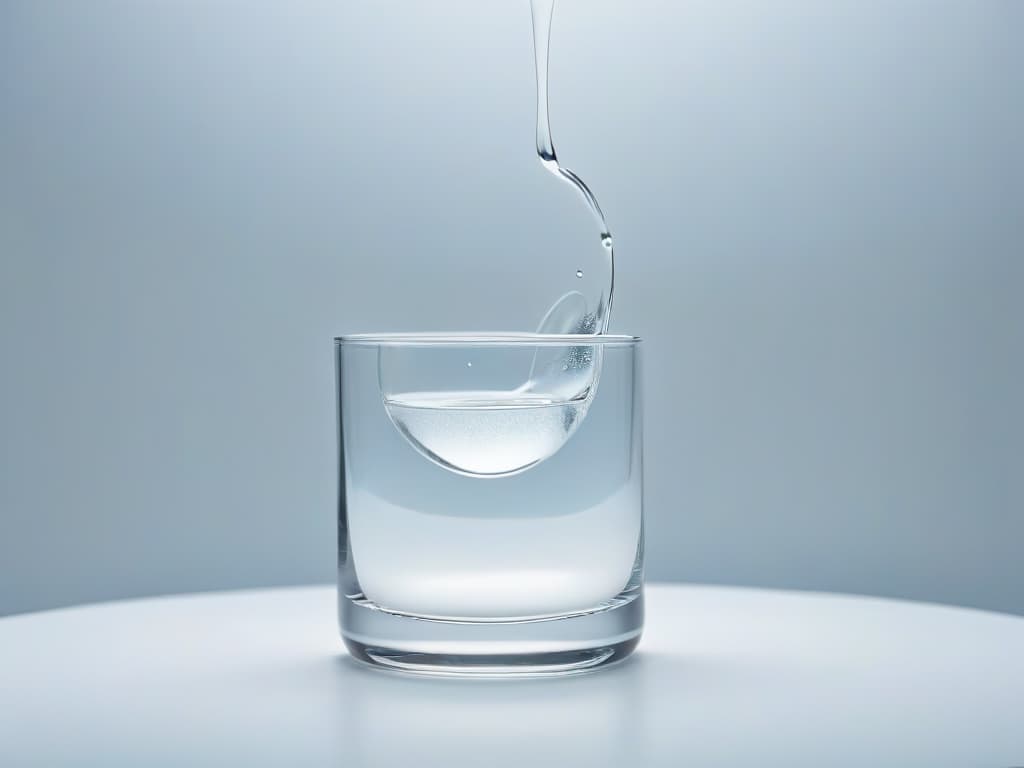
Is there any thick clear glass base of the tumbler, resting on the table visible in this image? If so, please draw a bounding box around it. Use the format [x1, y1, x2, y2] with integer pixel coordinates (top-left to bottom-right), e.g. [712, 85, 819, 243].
[339, 590, 643, 677]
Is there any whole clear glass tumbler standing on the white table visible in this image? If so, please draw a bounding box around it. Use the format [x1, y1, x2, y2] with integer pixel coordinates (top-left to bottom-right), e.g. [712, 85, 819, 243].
[335, 334, 643, 675]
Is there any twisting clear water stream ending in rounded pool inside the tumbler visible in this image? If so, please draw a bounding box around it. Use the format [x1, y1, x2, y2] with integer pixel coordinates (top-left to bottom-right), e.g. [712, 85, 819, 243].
[381, 0, 614, 477]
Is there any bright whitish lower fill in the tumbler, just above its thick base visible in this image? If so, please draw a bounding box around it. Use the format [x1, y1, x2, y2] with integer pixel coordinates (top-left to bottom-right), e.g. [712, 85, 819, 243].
[349, 478, 640, 621]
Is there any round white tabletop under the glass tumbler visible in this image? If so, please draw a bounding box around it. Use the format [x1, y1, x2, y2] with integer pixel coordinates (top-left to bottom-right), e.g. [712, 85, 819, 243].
[0, 586, 1024, 768]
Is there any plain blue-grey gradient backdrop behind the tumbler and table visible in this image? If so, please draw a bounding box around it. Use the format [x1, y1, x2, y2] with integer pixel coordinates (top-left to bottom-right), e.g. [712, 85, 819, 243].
[0, 0, 1024, 612]
